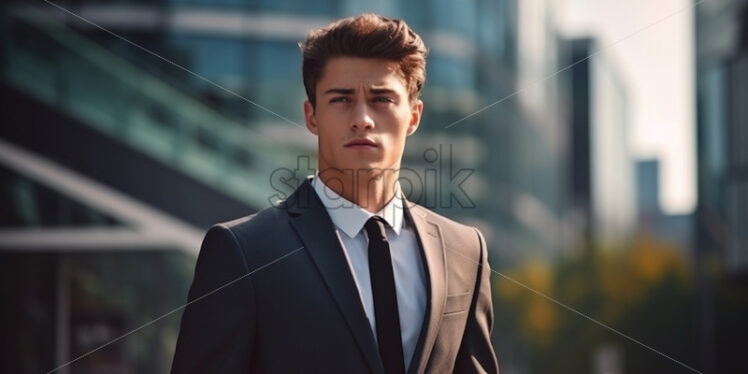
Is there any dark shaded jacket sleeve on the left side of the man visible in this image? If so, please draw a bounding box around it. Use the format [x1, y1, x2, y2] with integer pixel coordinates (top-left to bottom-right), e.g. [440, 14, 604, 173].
[171, 225, 255, 373]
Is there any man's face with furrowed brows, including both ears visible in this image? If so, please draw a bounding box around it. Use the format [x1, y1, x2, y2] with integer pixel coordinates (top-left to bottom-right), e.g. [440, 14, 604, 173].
[304, 57, 423, 182]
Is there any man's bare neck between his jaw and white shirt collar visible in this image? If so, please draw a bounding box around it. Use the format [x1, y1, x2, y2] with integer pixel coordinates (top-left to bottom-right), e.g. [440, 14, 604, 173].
[319, 168, 398, 213]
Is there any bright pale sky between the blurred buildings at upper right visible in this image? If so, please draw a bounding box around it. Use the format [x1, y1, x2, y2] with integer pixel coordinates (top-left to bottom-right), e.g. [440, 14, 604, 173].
[559, 0, 698, 214]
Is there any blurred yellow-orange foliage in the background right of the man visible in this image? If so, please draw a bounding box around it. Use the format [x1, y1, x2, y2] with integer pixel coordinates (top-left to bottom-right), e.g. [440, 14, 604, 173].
[494, 237, 690, 346]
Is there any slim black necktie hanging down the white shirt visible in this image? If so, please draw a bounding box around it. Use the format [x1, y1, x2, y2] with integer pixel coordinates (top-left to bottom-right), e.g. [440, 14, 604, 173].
[364, 216, 405, 374]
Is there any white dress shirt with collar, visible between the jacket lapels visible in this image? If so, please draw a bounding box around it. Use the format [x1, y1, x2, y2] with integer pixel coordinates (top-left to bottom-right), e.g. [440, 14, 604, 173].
[312, 171, 426, 371]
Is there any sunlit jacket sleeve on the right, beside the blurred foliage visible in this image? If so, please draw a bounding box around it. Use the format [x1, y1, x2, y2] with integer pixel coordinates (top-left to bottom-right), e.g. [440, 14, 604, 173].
[454, 229, 499, 373]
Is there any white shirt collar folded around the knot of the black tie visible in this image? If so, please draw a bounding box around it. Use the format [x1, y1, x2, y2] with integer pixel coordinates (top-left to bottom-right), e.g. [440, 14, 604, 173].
[312, 171, 403, 238]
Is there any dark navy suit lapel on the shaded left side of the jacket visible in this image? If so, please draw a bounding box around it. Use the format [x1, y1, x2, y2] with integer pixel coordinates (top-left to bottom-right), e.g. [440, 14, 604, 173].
[286, 179, 384, 374]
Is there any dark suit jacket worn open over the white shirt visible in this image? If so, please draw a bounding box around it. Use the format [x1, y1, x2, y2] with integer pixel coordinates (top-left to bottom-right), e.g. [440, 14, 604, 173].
[172, 179, 498, 374]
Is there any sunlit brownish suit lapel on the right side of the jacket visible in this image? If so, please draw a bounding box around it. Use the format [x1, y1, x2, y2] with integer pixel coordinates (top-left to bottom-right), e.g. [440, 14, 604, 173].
[403, 199, 447, 374]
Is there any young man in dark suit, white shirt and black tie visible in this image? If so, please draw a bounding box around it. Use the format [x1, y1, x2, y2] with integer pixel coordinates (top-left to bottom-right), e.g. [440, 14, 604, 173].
[172, 14, 498, 374]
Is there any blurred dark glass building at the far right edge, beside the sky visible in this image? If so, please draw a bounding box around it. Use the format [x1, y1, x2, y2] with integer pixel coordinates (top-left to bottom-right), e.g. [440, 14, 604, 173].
[697, 1, 748, 276]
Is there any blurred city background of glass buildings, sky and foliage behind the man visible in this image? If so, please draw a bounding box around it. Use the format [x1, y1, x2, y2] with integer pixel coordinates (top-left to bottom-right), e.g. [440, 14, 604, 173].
[0, 0, 748, 374]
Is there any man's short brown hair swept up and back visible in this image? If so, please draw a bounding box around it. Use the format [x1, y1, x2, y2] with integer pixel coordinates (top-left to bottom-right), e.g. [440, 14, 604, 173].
[299, 13, 428, 106]
